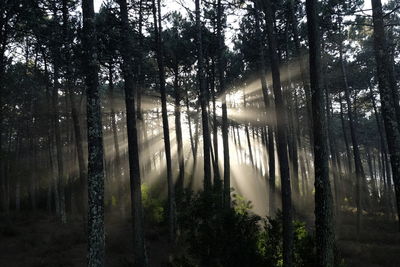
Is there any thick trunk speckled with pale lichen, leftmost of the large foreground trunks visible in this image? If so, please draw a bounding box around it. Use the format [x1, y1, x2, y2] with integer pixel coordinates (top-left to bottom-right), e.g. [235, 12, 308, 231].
[82, 0, 105, 267]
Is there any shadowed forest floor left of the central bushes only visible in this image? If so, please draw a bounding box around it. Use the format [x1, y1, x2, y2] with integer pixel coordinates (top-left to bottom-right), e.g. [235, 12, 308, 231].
[0, 213, 171, 267]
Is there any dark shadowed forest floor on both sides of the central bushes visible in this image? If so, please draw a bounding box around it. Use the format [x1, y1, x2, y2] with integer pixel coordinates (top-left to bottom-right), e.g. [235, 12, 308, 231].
[0, 213, 400, 267]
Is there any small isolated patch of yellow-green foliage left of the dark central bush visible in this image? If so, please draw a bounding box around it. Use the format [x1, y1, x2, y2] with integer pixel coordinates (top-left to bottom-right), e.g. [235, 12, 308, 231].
[141, 184, 165, 224]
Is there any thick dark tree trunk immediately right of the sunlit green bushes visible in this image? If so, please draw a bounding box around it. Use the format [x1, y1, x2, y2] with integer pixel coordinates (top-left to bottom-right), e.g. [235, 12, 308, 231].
[306, 0, 334, 266]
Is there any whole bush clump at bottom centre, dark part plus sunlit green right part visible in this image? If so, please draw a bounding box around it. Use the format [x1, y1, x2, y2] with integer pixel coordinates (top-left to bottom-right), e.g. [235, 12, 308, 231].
[174, 191, 315, 267]
